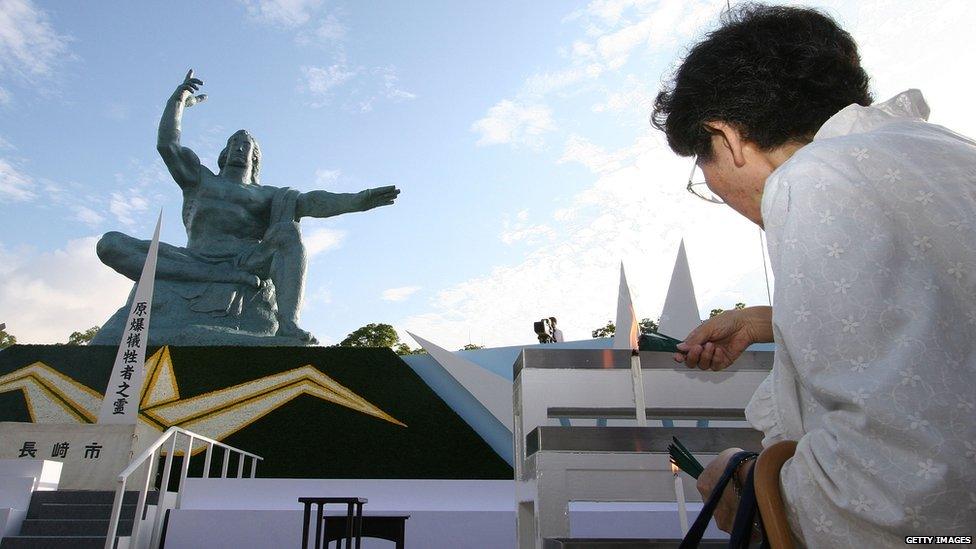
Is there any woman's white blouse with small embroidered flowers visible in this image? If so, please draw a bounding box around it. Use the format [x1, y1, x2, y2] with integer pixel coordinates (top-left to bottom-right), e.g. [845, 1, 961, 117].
[746, 90, 976, 548]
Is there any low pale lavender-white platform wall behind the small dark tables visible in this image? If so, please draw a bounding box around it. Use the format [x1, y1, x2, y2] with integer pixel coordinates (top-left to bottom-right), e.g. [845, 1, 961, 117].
[166, 478, 722, 549]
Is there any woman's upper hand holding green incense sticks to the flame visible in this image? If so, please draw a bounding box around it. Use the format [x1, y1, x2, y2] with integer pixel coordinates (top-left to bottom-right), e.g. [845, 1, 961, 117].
[674, 307, 773, 372]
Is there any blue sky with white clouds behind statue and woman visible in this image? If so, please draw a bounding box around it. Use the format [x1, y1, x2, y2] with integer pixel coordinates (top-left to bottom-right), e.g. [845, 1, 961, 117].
[0, 0, 976, 348]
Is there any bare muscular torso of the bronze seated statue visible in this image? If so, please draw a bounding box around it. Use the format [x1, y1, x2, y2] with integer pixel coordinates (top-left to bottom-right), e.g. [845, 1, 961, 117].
[183, 168, 274, 257]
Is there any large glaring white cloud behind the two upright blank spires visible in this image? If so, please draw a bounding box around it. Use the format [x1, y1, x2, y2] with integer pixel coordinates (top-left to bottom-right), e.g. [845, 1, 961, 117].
[397, 135, 765, 348]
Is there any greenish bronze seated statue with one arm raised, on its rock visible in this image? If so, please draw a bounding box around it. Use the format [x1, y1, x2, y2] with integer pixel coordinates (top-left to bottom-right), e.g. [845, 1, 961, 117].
[92, 70, 400, 345]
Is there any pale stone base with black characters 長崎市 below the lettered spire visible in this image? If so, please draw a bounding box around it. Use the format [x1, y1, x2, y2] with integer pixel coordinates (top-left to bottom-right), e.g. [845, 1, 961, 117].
[0, 421, 159, 490]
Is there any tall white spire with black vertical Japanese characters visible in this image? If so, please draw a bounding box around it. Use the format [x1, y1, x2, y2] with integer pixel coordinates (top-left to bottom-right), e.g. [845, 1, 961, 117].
[98, 210, 163, 424]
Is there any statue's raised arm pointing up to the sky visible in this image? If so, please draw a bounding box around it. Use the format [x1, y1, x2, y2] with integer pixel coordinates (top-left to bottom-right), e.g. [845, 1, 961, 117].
[156, 69, 207, 188]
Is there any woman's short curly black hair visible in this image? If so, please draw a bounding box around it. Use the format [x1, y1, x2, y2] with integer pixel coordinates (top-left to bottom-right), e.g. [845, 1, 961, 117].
[651, 4, 872, 160]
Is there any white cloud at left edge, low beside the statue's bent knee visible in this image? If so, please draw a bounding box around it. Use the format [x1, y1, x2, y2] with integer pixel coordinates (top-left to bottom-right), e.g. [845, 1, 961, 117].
[0, 237, 132, 343]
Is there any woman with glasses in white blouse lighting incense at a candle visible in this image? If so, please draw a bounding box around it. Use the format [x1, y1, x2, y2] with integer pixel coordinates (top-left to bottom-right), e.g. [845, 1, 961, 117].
[652, 4, 976, 548]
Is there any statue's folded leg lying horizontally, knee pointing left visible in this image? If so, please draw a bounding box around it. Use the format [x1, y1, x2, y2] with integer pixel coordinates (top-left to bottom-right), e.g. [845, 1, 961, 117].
[95, 231, 261, 287]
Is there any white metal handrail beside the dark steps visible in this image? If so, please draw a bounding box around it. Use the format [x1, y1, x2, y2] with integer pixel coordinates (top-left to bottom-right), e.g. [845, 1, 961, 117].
[105, 427, 264, 549]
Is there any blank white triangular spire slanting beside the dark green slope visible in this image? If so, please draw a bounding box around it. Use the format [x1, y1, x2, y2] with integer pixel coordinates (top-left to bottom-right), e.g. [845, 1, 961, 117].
[407, 332, 513, 431]
